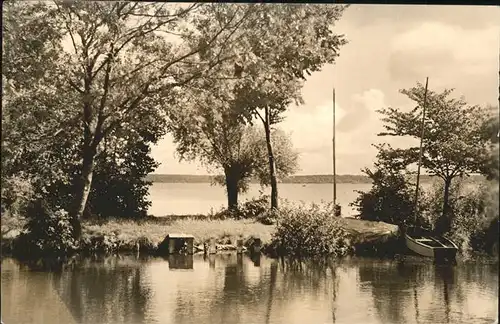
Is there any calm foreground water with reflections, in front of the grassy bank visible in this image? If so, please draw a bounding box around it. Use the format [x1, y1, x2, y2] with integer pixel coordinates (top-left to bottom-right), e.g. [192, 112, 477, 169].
[1, 255, 498, 324]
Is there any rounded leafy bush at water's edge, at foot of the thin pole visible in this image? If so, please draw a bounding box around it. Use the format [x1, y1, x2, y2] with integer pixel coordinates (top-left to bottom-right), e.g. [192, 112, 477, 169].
[272, 204, 349, 257]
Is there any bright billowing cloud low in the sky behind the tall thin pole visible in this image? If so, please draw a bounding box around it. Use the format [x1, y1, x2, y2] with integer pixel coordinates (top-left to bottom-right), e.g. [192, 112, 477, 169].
[280, 89, 386, 174]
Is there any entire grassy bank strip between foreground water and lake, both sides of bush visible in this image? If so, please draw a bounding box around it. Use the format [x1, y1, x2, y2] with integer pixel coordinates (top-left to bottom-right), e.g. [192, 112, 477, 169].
[1, 215, 398, 255]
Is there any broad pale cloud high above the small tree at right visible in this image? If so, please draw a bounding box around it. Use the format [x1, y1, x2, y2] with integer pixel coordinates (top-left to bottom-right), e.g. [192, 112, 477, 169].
[389, 21, 499, 86]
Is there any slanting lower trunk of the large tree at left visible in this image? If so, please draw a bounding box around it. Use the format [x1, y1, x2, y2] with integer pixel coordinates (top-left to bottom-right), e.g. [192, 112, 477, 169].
[72, 146, 96, 238]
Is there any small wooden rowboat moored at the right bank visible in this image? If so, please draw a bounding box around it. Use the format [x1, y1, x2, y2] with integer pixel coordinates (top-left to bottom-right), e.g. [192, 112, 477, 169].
[405, 227, 458, 261]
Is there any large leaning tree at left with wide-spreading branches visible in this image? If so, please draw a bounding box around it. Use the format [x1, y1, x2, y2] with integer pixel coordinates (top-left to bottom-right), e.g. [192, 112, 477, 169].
[1, 1, 254, 236]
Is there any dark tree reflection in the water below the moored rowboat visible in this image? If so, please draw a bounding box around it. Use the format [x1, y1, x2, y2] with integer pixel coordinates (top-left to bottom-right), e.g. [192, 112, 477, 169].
[359, 260, 491, 323]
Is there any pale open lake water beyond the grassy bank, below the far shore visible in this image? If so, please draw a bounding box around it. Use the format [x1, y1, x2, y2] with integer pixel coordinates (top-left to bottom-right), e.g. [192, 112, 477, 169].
[149, 183, 371, 216]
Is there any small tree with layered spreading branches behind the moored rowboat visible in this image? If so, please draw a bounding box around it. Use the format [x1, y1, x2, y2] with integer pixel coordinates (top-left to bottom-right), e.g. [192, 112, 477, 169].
[379, 83, 489, 233]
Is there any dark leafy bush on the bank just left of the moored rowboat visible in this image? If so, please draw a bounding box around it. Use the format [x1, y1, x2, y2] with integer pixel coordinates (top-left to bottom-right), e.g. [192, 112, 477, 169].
[350, 145, 423, 227]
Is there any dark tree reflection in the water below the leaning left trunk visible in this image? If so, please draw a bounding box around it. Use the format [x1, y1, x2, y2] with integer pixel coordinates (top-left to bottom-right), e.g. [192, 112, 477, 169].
[53, 256, 151, 323]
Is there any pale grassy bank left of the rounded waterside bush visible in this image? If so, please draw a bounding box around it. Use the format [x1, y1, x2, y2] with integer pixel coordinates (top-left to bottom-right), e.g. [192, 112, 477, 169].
[2, 216, 275, 254]
